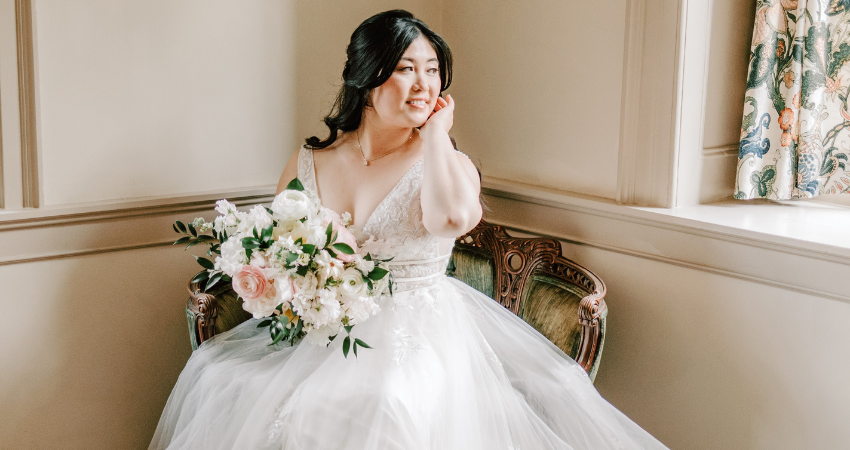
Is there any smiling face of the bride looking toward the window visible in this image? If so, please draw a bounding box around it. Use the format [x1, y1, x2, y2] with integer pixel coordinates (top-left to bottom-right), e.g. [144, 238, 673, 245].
[371, 36, 441, 128]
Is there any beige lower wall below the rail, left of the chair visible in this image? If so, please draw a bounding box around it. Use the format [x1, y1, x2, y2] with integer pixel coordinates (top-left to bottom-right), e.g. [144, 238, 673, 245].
[0, 247, 197, 449]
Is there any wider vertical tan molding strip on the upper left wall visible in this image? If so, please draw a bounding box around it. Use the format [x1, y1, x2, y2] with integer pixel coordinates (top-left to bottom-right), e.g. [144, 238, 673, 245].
[15, 0, 42, 208]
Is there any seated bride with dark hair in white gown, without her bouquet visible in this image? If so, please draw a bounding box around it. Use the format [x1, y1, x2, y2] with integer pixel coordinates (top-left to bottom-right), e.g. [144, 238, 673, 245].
[150, 7, 665, 450]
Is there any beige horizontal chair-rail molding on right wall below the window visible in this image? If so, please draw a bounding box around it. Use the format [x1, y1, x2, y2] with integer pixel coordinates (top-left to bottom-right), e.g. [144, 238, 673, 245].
[484, 179, 850, 303]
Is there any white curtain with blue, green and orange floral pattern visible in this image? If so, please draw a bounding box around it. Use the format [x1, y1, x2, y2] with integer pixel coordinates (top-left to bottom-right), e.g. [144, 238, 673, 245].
[735, 0, 850, 199]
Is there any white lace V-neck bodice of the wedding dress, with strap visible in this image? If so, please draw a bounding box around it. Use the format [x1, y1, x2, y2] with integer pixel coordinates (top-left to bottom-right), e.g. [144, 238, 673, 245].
[298, 146, 458, 288]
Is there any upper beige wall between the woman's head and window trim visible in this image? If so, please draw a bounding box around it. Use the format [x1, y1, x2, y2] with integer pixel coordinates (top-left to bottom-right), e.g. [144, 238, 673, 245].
[443, 0, 626, 198]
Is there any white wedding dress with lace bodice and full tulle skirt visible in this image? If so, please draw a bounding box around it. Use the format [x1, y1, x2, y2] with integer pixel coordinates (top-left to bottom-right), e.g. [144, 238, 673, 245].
[150, 148, 666, 450]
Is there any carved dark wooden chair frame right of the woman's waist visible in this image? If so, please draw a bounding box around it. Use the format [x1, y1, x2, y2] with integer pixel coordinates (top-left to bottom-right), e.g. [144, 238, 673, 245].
[455, 220, 608, 373]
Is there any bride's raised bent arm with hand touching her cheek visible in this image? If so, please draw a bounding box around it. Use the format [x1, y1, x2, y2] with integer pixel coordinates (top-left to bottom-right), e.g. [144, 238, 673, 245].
[419, 95, 483, 238]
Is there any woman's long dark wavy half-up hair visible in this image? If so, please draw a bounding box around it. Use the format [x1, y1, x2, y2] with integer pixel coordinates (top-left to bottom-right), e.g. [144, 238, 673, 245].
[306, 9, 452, 149]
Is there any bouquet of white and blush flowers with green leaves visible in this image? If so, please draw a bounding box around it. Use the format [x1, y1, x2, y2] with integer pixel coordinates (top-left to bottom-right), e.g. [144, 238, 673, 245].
[174, 178, 392, 357]
